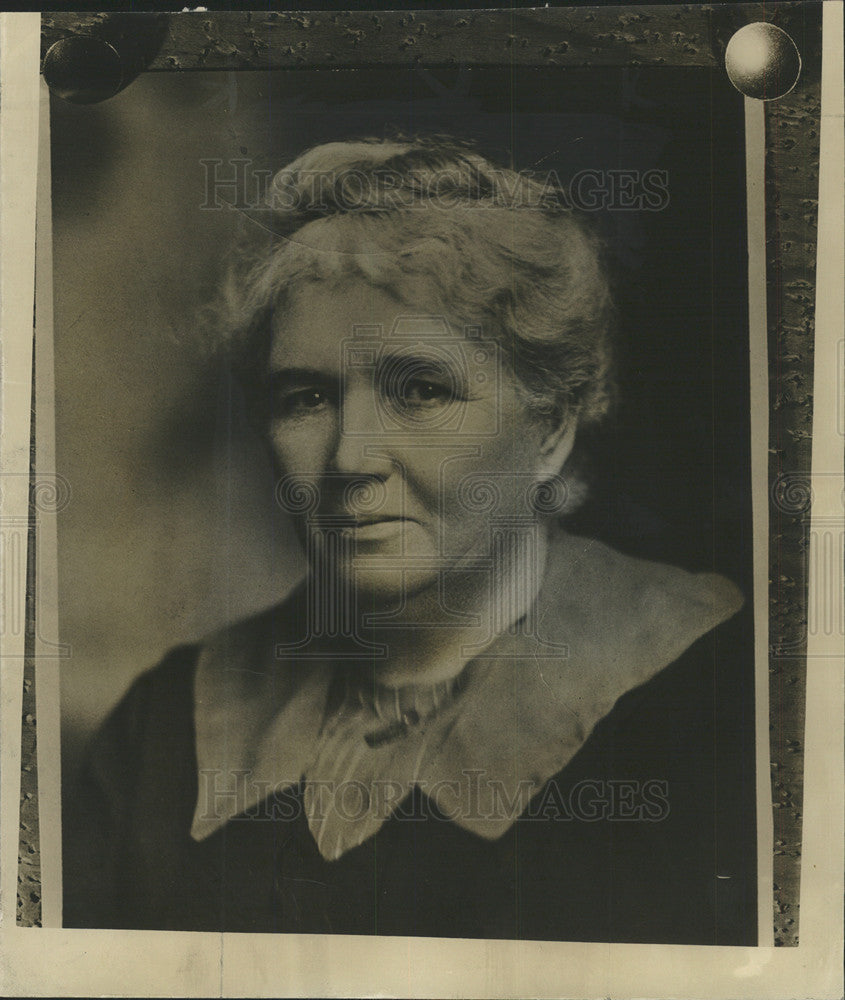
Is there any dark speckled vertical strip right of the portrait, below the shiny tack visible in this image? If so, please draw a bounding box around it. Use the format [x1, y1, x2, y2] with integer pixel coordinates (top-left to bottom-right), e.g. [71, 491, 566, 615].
[766, 4, 816, 945]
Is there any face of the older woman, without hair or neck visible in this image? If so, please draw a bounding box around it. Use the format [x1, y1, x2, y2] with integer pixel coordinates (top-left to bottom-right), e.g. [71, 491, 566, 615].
[267, 279, 560, 597]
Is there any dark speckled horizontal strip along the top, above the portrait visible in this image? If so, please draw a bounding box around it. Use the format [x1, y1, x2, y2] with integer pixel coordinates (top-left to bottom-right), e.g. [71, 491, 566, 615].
[42, 4, 718, 70]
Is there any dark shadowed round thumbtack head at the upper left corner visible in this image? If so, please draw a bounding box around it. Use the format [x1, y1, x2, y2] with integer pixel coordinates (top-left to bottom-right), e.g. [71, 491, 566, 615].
[43, 35, 123, 104]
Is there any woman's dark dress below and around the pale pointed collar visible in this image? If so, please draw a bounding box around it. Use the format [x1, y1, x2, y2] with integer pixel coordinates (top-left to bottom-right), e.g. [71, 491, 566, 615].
[64, 600, 757, 945]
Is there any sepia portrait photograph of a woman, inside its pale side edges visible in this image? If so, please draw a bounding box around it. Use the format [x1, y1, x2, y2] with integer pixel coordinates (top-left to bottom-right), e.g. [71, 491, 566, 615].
[52, 50, 758, 945]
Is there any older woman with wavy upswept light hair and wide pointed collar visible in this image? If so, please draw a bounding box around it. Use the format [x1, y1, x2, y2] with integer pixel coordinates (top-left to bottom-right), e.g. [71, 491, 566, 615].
[65, 137, 755, 944]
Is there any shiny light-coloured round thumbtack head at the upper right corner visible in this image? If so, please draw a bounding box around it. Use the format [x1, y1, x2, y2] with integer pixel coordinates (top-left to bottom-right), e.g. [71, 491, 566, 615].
[725, 21, 801, 101]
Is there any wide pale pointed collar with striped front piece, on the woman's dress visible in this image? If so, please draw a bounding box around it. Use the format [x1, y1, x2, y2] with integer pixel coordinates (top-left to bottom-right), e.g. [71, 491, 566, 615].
[191, 533, 743, 858]
